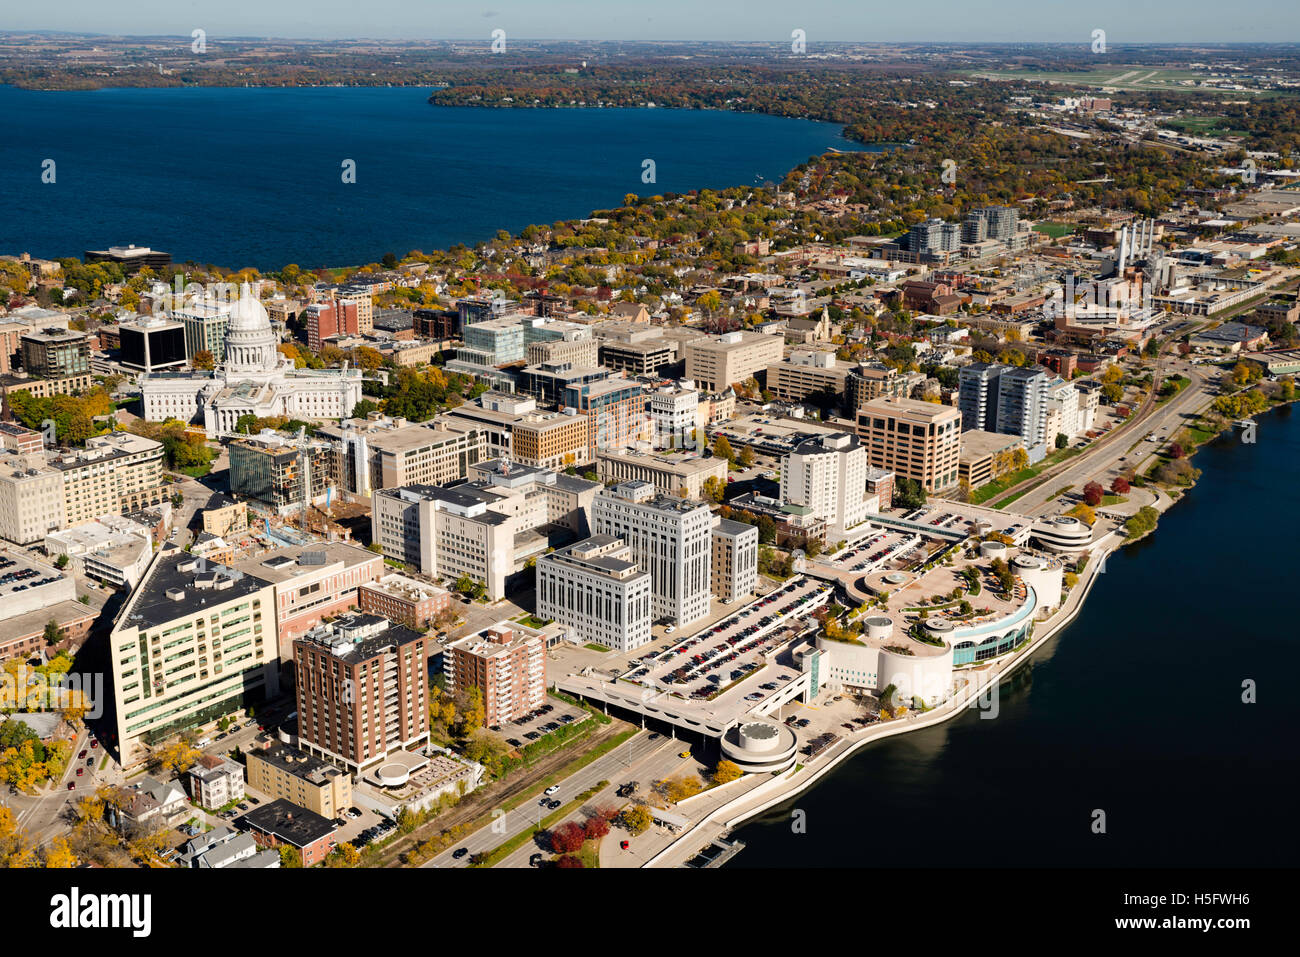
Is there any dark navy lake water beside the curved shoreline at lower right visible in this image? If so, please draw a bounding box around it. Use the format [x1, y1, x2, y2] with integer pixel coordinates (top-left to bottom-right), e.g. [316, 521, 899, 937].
[728, 408, 1300, 867]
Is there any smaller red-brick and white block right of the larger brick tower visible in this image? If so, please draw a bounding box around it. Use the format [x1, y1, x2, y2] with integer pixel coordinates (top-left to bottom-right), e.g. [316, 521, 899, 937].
[442, 622, 546, 724]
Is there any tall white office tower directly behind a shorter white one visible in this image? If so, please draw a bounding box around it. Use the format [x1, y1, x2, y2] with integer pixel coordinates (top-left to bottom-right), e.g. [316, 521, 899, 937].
[592, 482, 714, 628]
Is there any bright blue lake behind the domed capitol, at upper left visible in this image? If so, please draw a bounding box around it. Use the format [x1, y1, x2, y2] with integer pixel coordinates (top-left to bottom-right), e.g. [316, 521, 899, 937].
[0, 87, 862, 269]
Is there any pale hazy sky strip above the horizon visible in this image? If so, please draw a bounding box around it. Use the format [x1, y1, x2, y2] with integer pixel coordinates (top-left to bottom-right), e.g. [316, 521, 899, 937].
[0, 0, 1300, 43]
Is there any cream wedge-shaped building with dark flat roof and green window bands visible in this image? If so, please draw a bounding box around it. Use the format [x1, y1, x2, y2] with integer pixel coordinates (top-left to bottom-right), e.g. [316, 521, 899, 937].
[109, 546, 280, 767]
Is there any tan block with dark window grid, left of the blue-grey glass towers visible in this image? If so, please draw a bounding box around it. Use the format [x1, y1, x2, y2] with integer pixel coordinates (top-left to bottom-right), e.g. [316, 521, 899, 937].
[857, 397, 962, 492]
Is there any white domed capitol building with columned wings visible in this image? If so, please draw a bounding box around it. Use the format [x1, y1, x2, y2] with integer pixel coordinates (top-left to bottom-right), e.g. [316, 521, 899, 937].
[140, 283, 361, 438]
